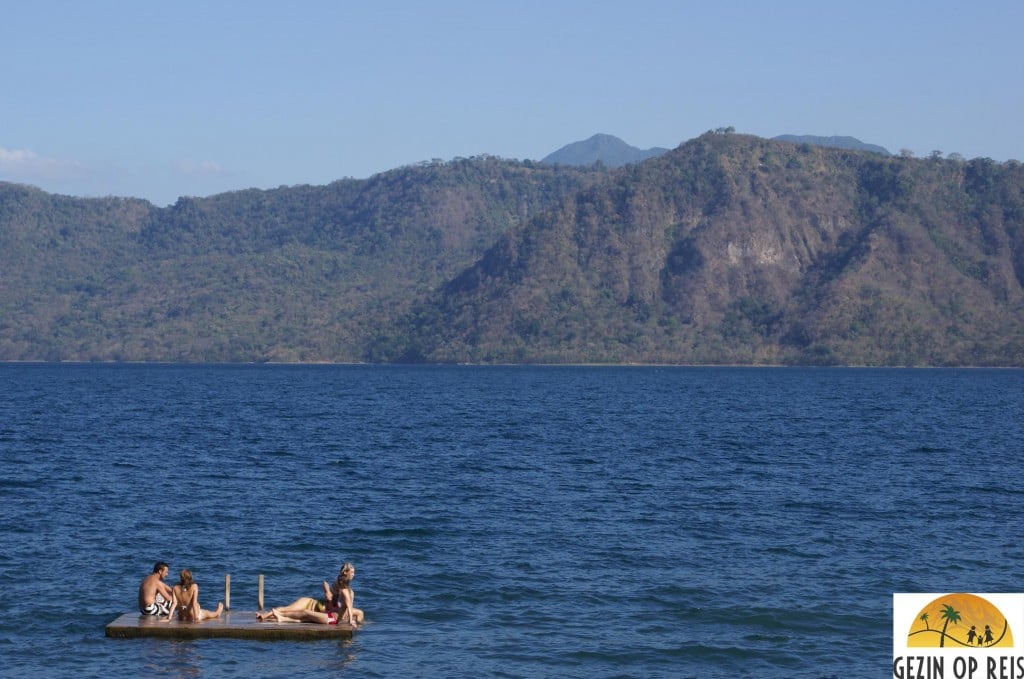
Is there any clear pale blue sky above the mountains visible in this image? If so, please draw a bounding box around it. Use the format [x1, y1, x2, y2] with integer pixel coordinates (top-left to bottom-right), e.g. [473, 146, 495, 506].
[0, 0, 1024, 205]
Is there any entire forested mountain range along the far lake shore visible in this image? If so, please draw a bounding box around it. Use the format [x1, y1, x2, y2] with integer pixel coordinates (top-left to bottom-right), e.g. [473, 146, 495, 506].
[0, 131, 1024, 366]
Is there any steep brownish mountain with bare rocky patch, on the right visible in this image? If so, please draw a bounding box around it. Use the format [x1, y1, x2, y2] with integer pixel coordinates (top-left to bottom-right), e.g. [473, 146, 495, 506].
[399, 134, 1024, 365]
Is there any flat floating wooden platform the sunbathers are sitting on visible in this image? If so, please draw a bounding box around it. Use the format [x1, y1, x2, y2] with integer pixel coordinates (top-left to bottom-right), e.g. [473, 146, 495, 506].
[106, 610, 355, 641]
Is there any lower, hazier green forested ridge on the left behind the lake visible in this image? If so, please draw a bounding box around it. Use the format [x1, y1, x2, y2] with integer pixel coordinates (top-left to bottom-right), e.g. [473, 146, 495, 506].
[0, 157, 603, 362]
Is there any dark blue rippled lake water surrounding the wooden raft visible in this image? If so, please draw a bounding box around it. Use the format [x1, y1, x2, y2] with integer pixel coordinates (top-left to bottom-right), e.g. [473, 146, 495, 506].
[0, 365, 1024, 678]
